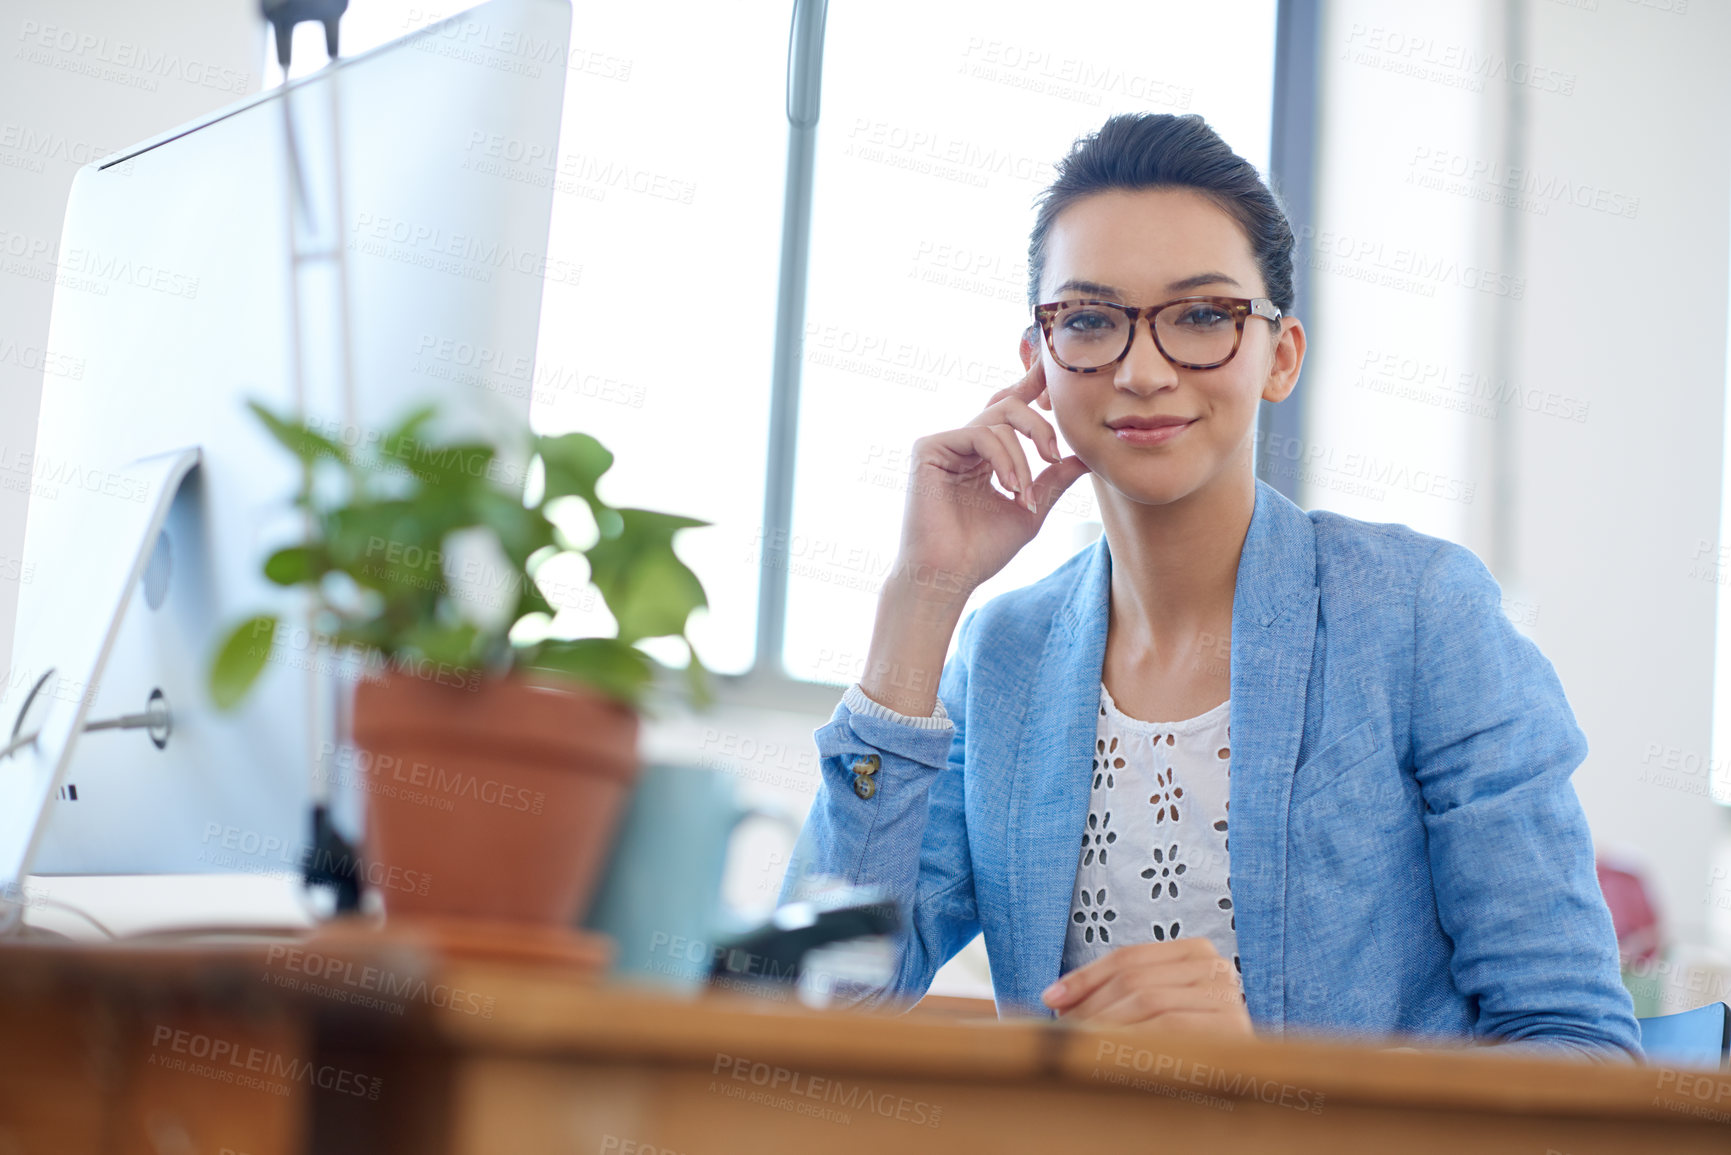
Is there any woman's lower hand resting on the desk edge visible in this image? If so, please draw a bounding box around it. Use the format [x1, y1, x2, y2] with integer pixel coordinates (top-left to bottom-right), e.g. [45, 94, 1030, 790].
[1040, 939, 1252, 1036]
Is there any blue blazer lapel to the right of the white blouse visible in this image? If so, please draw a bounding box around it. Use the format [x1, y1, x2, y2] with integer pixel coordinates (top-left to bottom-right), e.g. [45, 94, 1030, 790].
[1227, 481, 1317, 1030]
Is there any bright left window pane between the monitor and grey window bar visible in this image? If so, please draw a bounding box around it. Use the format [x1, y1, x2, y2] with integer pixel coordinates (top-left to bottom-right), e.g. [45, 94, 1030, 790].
[265, 0, 788, 674]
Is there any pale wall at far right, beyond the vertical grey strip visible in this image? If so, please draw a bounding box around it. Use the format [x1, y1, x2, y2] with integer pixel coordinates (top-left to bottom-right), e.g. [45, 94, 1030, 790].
[1508, 0, 1731, 945]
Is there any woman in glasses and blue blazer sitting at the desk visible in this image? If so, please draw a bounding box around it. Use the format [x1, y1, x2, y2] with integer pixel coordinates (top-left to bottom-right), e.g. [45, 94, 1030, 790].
[784, 114, 1639, 1058]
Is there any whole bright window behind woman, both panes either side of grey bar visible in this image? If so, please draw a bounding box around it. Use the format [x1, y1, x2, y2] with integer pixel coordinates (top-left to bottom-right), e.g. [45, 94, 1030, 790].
[267, 0, 1276, 686]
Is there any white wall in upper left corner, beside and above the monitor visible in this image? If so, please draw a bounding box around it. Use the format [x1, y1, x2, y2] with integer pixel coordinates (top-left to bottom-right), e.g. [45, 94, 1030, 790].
[0, 0, 263, 663]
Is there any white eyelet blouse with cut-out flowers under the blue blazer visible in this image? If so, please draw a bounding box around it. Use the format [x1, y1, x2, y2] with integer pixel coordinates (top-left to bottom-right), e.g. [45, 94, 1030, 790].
[1063, 684, 1243, 973]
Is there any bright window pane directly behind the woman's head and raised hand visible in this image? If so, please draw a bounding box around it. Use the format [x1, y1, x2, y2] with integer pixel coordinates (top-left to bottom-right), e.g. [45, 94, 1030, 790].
[782, 0, 1274, 684]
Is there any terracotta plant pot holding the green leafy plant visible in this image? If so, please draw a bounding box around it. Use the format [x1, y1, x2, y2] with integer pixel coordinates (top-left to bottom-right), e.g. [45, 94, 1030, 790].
[355, 670, 637, 926]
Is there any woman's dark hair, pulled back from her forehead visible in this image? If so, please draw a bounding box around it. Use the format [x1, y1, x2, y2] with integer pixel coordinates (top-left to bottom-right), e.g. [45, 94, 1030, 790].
[1028, 113, 1293, 313]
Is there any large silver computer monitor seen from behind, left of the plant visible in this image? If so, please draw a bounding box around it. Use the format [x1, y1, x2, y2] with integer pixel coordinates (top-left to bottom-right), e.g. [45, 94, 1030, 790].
[0, 0, 580, 914]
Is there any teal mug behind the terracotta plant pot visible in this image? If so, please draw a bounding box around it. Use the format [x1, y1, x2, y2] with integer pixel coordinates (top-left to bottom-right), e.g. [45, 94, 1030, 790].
[583, 765, 800, 990]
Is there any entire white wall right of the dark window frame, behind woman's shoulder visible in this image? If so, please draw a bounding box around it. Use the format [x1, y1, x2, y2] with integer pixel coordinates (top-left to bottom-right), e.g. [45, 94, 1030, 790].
[1300, 0, 1731, 983]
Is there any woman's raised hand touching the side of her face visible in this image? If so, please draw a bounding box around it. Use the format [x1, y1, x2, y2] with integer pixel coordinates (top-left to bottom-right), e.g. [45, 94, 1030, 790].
[895, 357, 1087, 604]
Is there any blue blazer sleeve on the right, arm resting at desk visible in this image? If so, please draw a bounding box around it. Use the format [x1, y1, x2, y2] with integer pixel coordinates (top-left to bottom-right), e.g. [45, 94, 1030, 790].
[1412, 544, 1641, 1061]
